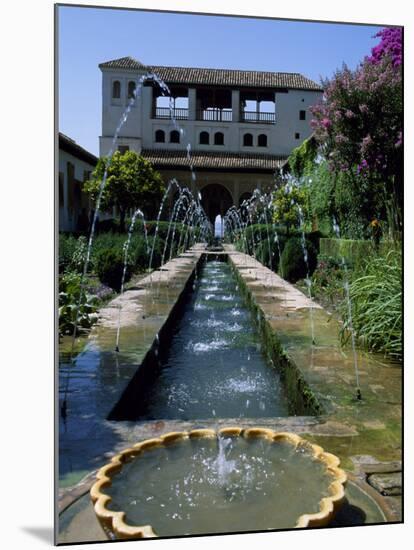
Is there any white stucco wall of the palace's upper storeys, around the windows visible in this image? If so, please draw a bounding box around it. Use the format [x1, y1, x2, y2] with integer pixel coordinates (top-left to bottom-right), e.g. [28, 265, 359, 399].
[100, 69, 322, 160]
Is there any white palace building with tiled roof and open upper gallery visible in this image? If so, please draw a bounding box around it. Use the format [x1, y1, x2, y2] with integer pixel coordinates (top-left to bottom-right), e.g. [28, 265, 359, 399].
[99, 57, 323, 221]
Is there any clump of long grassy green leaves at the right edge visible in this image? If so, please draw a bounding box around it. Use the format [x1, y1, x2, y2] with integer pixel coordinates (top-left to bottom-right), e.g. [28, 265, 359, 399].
[341, 250, 402, 360]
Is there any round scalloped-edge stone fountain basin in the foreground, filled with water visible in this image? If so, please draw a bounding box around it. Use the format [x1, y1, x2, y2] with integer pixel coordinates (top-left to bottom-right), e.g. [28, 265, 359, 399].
[91, 428, 346, 538]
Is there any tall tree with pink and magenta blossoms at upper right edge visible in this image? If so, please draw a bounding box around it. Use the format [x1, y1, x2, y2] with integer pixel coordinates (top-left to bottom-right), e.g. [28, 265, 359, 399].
[311, 28, 403, 237]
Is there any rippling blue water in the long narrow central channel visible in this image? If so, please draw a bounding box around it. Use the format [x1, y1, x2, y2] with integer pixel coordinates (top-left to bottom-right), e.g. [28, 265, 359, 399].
[137, 261, 288, 420]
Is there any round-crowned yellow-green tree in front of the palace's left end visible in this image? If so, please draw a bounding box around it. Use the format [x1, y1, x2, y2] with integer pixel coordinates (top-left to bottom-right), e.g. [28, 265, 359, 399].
[83, 151, 165, 231]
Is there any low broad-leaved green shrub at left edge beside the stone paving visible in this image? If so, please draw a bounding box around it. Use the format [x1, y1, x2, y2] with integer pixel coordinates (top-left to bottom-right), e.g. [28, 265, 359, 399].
[59, 272, 98, 334]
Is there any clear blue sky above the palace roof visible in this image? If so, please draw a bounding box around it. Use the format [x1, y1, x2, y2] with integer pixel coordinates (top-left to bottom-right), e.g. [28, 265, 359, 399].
[58, 6, 380, 154]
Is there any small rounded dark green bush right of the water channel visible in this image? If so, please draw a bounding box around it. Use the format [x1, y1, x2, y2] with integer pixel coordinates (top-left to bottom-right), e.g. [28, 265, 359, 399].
[280, 237, 317, 283]
